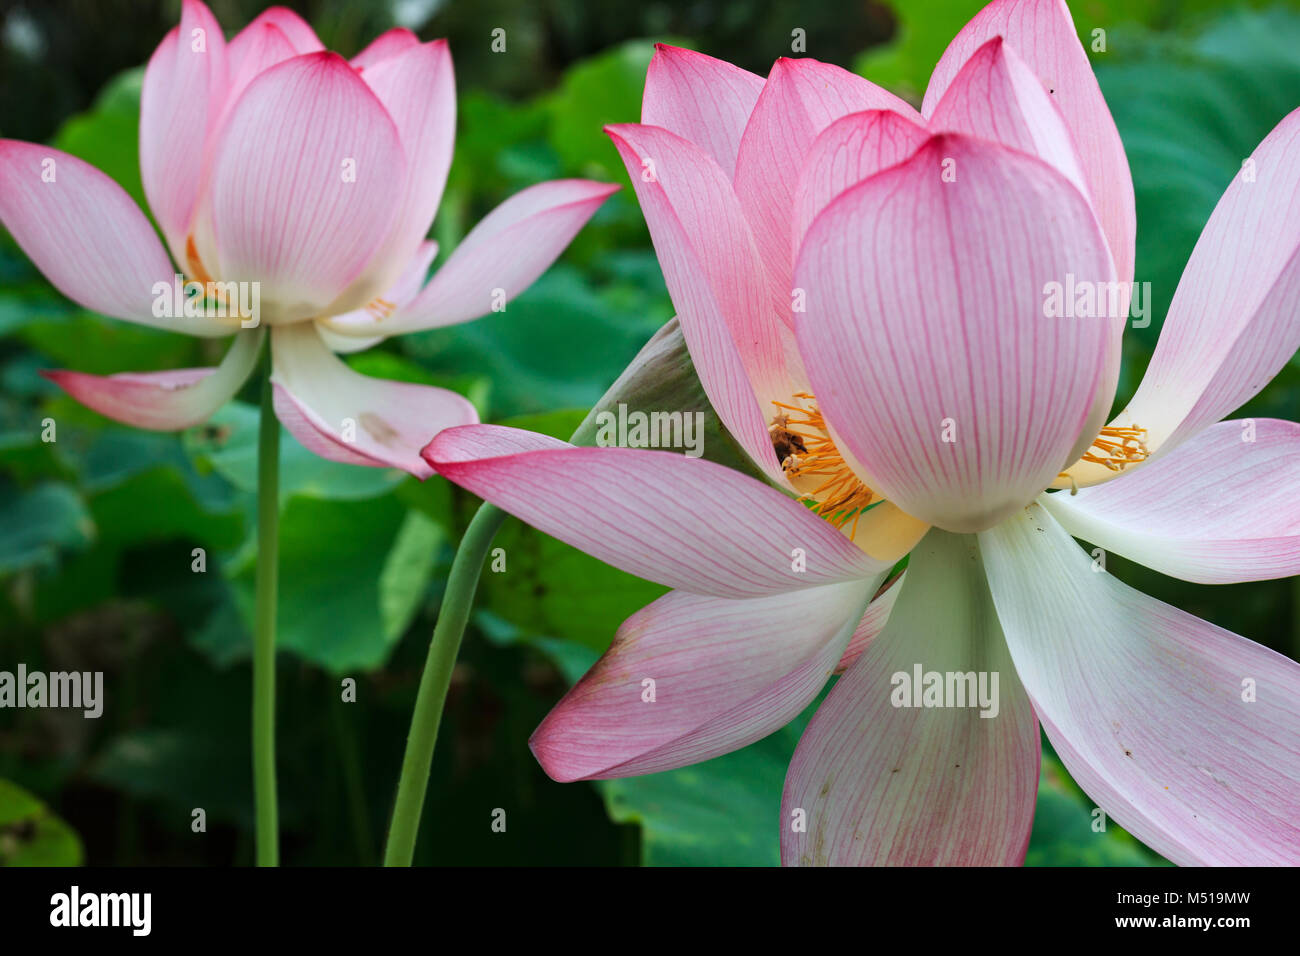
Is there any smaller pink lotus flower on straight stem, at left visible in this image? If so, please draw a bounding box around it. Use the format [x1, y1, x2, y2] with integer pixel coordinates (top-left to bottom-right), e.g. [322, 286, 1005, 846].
[0, 0, 615, 477]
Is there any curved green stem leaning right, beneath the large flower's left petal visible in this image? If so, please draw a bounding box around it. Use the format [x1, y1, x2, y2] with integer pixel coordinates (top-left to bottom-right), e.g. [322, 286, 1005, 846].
[384, 502, 506, 866]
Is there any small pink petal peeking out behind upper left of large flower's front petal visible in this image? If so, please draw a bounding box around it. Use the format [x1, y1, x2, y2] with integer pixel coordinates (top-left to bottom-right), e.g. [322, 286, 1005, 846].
[793, 109, 930, 255]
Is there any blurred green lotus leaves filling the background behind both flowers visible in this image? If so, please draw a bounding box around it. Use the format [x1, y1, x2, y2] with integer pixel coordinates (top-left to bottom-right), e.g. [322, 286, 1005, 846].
[0, 0, 1300, 865]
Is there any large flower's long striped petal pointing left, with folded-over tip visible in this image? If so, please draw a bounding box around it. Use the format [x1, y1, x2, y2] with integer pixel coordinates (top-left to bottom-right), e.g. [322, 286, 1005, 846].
[424, 425, 892, 598]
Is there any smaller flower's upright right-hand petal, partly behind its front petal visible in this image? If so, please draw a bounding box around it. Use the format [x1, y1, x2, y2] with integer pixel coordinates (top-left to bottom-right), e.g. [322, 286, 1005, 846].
[329, 40, 456, 312]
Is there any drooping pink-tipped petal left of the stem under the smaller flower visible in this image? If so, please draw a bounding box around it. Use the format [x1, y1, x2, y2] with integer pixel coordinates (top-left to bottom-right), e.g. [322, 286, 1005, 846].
[42, 329, 265, 432]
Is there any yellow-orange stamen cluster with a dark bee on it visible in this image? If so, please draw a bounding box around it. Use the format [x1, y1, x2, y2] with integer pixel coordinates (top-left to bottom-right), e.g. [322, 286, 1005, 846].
[767, 392, 874, 538]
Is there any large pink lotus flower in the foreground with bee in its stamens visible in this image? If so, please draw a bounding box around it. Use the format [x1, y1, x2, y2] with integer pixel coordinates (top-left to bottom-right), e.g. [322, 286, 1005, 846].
[425, 0, 1300, 864]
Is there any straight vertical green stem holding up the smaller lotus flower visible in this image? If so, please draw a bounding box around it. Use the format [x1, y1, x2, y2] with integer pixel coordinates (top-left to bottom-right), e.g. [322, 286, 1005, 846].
[252, 363, 280, 866]
